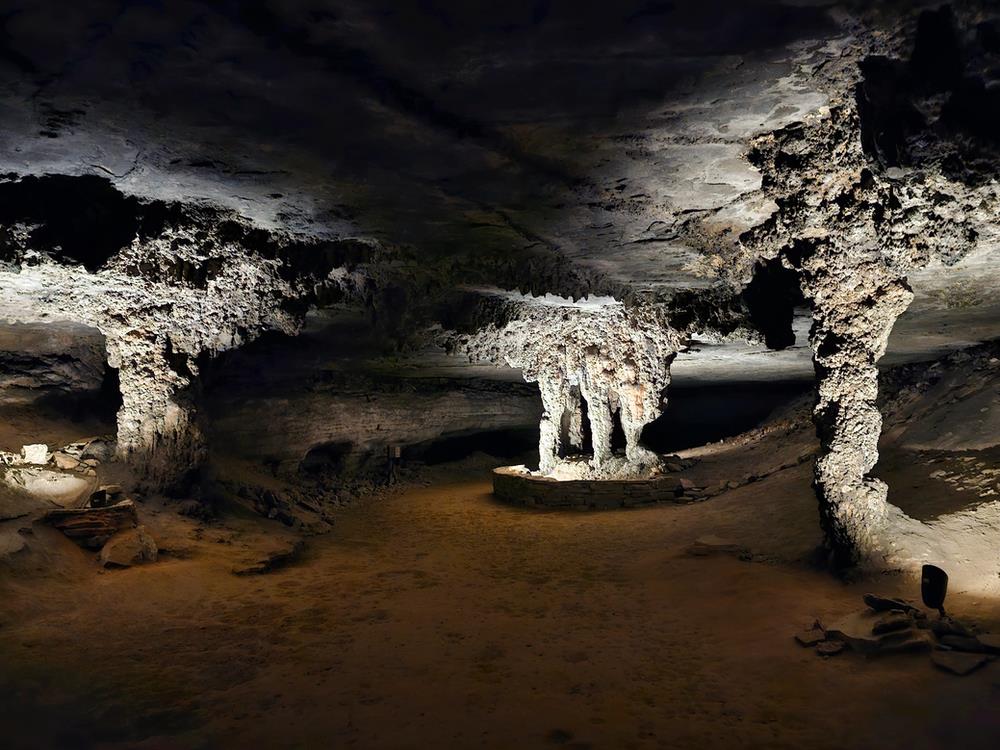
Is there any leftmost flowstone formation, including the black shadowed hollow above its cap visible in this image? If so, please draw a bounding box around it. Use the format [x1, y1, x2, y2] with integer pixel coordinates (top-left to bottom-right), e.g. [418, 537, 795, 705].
[0, 178, 372, 485]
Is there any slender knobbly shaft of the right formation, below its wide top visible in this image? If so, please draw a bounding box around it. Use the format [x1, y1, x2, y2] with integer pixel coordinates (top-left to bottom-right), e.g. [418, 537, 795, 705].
[802, 257, 913, 567]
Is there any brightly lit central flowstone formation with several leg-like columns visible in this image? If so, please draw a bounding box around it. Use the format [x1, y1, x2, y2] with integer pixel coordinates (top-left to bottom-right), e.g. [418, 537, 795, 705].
[455, 299, 681, 479]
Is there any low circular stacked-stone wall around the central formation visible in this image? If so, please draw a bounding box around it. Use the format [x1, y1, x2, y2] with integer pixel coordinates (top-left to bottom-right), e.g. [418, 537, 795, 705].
[493, 466, 724, 508]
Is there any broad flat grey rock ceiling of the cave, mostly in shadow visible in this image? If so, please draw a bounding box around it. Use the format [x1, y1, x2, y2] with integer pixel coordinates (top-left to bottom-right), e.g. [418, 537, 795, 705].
[0, 0, 1000, 380]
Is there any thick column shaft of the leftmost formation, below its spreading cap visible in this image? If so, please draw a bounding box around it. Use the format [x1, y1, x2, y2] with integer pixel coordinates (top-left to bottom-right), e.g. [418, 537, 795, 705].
[108, 332, 206, 487]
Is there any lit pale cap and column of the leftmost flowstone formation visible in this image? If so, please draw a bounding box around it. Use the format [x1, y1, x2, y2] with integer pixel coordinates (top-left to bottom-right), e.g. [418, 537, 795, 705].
[0, 188, 360, 485]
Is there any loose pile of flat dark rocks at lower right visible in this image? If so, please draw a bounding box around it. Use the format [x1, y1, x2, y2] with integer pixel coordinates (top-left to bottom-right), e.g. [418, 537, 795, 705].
[794, 594, 1000, 675]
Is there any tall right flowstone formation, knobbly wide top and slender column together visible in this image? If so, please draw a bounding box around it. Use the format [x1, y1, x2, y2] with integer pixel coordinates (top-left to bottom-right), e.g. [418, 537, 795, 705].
[741, 8, 998, 566]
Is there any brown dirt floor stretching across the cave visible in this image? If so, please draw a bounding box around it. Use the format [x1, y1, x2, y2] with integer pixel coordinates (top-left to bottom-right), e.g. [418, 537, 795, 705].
[0, 436, 1000, 749]
